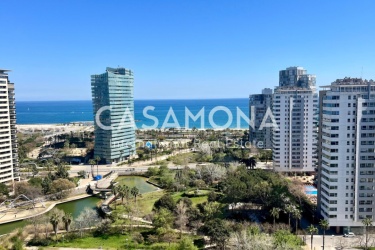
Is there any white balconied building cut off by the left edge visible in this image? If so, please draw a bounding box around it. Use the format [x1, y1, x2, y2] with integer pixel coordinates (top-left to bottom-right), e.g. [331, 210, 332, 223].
[0, 69, 19, 184]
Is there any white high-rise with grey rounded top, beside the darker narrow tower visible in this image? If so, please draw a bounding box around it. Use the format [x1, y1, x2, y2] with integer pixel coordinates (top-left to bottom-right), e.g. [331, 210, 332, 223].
[272, 67, 318, 172]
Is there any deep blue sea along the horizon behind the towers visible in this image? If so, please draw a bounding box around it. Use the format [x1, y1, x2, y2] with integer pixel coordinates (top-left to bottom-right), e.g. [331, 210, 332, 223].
[16, 98, 249, 129]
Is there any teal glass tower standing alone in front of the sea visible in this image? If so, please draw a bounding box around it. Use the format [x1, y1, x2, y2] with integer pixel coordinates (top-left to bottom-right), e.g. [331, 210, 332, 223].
[91, 67, 136, 163]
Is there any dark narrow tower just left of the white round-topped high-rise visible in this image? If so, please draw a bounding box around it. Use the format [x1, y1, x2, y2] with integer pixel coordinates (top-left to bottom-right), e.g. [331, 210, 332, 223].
[249, 88, 272, 149]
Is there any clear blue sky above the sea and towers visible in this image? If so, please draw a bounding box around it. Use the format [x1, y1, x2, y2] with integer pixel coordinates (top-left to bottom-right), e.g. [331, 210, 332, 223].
[0, 0, 375, 101]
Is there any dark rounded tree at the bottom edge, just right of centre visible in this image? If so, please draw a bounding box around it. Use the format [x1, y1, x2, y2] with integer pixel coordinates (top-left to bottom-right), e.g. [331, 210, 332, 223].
[200, 218, 230, 249]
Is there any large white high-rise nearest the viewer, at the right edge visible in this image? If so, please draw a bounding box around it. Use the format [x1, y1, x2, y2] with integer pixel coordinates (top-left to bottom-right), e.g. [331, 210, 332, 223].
[318, 78, 375, 232]
